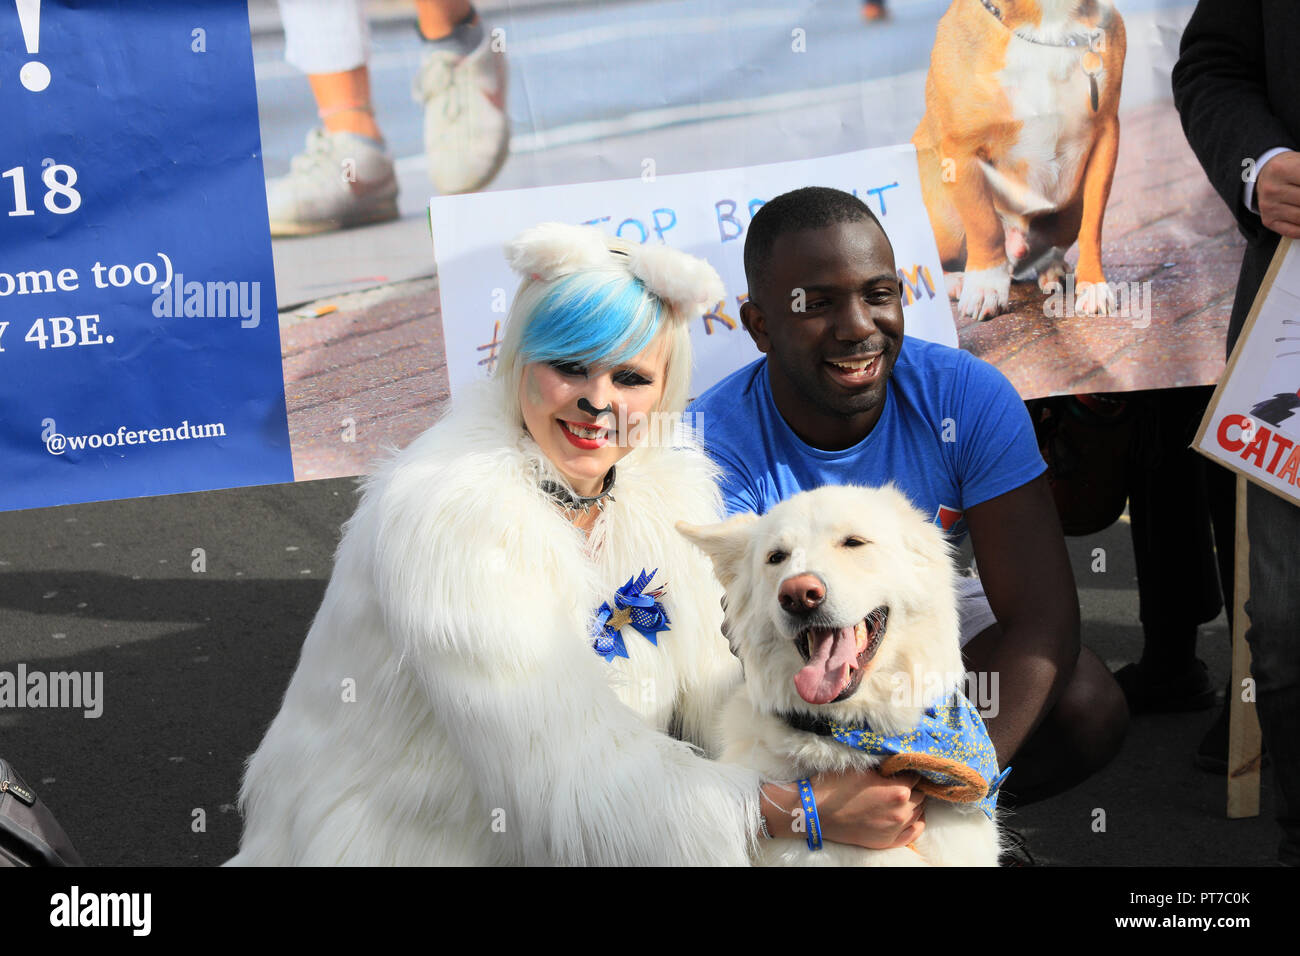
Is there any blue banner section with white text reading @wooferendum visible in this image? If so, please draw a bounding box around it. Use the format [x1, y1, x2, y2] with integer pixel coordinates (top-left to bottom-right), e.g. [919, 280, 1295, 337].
[0, 0, 294, 510]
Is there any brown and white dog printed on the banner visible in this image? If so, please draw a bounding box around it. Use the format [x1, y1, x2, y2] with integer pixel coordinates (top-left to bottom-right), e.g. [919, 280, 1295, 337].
[913, 0, 1126, 319]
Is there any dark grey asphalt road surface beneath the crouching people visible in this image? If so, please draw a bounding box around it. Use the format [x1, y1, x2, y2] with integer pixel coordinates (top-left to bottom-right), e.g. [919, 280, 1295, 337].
[0, 479, 1278, 866]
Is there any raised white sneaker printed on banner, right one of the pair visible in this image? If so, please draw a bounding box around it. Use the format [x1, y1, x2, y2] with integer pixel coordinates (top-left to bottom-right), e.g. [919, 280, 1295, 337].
[412, 31, 510, 195]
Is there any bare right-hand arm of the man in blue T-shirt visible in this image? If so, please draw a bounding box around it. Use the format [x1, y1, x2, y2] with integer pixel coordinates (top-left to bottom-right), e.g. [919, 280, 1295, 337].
[966, 475, 1079, 766]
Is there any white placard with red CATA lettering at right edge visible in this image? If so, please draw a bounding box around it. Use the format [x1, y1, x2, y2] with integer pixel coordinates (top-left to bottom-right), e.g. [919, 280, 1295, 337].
[1193, 239, 1300, 503]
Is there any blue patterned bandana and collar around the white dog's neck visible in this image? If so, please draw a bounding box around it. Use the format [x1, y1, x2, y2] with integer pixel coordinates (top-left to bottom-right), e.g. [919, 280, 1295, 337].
[777, 691, 1011, 819]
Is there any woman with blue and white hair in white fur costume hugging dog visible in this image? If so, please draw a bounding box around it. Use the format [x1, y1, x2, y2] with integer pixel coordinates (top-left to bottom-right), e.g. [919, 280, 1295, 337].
[231, 224, 920, 865]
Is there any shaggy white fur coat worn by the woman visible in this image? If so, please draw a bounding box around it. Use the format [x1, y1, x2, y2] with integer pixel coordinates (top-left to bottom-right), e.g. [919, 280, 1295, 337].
[230, 384, 761, 865]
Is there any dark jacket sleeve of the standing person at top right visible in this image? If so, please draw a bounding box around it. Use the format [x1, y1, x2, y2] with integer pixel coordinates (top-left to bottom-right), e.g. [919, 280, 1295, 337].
[1173, 0, 1296, 242]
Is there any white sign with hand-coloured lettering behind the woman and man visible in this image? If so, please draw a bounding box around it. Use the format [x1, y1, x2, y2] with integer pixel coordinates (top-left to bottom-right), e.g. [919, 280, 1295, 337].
[429, 146, 957, 395]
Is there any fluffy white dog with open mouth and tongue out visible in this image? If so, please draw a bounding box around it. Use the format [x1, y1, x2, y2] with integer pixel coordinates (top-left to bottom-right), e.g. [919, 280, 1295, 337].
[677, 486, 998, 866]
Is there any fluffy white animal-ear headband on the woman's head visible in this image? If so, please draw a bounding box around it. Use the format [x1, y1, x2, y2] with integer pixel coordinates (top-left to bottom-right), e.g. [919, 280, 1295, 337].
[506, 222, 727, 319]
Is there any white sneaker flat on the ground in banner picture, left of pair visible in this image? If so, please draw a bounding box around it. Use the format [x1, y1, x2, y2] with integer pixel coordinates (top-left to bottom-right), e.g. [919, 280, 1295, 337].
[267, 129, 398, 237]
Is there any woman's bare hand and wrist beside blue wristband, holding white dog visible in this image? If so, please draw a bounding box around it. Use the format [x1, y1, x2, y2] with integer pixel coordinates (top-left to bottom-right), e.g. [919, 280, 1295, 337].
[762, 770, 926, 849]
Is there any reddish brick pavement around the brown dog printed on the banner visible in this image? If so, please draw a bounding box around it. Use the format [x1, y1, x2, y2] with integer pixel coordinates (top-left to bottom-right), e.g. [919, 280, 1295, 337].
[958, 103, 1244, 398]
